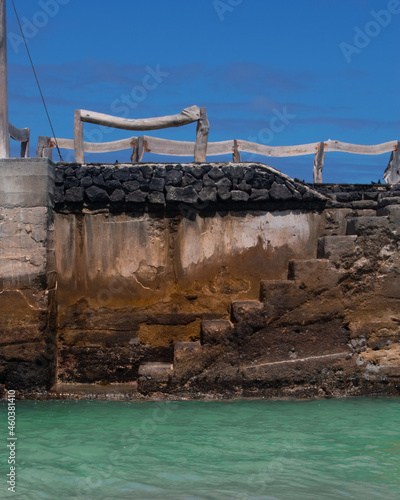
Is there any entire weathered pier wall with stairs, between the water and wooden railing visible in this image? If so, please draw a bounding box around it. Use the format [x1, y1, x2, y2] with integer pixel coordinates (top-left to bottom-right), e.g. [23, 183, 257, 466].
[0, 160, 400, 397]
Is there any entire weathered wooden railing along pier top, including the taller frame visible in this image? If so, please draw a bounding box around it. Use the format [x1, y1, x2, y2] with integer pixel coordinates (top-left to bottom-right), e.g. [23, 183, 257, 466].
[37, 106, 400, 183]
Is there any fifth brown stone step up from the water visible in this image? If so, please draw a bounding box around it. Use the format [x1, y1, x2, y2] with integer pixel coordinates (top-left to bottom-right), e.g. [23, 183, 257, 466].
[260, 280, 306, 316]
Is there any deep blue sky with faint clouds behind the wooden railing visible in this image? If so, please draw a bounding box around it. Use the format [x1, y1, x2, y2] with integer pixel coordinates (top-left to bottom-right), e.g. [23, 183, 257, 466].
[7, 0, 400, 183]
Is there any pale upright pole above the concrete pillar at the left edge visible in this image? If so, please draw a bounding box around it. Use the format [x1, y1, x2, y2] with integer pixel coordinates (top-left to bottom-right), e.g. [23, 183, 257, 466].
[0, 0, 10, 158]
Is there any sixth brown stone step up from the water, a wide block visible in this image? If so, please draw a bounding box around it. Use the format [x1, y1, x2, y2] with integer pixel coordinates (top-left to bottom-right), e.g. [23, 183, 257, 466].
[288, 259, 340, 291]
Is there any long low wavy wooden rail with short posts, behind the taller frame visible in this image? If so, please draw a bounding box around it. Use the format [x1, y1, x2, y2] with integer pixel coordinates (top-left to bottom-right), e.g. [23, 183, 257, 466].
[38, 133, 400, 183]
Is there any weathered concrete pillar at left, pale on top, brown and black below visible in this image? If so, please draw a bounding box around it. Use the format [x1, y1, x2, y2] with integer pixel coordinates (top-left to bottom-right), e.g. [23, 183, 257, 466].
[0, 158, 56, 390]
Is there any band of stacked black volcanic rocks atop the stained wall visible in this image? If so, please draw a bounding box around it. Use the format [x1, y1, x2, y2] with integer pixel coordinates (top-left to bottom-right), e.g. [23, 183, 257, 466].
[55, 163, 327, 211]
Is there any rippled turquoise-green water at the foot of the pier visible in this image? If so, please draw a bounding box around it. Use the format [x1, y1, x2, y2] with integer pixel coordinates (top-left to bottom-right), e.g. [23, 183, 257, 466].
[0, 398, 400, 500]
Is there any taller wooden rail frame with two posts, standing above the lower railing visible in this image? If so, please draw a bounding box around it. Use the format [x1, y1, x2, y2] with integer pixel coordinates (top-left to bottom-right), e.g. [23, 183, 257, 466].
[74, 106, 209, 163]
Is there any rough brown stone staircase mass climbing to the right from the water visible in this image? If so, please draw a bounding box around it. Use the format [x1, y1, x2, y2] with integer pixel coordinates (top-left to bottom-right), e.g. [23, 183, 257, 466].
[135, 206, 400, 397]
